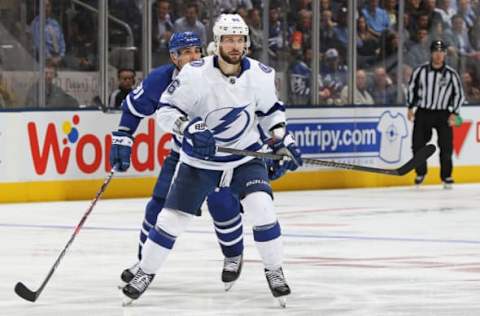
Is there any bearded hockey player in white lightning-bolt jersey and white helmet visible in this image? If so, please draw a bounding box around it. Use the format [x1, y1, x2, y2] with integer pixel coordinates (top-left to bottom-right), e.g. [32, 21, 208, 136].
[123, 14, 302, 307]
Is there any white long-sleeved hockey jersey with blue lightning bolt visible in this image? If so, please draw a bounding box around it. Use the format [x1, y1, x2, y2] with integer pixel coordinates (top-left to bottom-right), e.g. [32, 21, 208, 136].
[157, 56, 285, 170]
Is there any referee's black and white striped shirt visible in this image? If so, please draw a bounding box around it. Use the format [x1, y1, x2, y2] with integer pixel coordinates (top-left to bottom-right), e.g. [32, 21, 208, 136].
[407, 62, 465, 114]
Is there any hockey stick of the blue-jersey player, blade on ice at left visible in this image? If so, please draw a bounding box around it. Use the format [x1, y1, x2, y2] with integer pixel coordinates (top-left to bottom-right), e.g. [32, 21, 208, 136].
[15, 168, 115, 302]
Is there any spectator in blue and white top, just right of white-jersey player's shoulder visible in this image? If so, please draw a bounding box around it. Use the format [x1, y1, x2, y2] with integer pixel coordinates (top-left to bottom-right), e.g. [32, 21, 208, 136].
[289, 47, 312, 104]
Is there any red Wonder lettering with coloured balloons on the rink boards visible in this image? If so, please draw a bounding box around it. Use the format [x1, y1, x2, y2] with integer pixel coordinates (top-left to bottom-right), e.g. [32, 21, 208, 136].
[27, 115, 172, 175]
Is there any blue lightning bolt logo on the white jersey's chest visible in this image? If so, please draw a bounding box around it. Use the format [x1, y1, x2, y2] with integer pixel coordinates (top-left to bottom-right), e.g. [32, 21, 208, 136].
[205, 104, 251, 142]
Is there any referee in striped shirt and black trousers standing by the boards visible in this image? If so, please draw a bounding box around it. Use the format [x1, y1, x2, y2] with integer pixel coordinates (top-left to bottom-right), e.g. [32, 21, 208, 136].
[407, 40, 464, 189]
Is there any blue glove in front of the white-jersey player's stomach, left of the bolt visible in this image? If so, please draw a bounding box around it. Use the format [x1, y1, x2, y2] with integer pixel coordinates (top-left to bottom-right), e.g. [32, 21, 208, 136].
[182, 117, 217, 160]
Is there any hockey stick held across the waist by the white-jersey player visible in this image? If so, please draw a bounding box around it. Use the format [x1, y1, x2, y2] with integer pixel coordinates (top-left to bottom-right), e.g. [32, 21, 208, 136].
[217, 144, 435, 176]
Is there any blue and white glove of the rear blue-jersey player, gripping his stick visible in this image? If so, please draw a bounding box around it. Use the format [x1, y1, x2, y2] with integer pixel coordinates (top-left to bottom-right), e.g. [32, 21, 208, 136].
[110, 131, 133, 172]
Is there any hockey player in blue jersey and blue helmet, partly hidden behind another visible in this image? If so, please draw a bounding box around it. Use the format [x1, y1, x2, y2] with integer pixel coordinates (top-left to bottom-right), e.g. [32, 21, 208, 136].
[110, 32, 258, 291]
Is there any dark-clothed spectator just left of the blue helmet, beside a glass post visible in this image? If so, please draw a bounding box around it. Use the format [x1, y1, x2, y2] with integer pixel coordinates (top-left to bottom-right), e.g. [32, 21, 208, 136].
[152, 0, 174, 66]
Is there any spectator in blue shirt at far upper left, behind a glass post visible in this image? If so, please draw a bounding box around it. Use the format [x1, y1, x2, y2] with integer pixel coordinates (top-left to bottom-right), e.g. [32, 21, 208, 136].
[31, 0, 65, 66]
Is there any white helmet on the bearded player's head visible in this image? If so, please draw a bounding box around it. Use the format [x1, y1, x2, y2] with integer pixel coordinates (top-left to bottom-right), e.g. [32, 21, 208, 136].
[213, 14, 250, 56]
